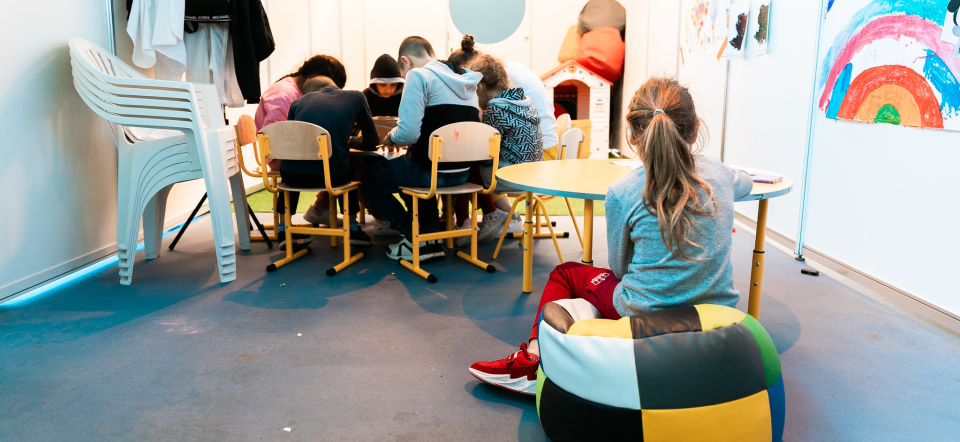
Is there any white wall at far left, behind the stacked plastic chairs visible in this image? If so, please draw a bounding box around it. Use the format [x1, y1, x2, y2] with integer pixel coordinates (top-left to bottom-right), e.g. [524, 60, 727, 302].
[0, 0, 117, 298]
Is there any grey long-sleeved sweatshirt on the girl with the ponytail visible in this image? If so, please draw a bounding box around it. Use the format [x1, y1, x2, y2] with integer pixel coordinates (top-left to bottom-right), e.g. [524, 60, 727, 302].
[606, 155, 753, 316]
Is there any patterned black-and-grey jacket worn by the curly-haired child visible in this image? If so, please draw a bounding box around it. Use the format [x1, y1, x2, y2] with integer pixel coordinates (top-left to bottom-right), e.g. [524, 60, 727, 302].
[483, 87, 543, 167]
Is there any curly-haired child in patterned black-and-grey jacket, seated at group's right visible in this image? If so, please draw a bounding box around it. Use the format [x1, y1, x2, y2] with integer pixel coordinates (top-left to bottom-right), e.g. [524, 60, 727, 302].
[456, 54, 543, 244]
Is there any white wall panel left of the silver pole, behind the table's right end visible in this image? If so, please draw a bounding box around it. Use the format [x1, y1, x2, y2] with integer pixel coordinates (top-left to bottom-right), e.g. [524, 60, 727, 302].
[724, 1, 820, 240]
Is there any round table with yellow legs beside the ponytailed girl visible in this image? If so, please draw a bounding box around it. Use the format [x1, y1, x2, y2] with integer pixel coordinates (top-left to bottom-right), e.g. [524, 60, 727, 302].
[497, 160, 793, 318]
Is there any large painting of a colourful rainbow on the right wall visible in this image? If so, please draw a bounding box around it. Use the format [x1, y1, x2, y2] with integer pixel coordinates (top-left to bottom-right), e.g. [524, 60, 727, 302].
[817, 0, 960, 131]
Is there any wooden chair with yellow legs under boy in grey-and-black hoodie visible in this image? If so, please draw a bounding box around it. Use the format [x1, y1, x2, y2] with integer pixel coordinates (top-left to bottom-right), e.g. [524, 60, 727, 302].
[400, 122, 500, 283]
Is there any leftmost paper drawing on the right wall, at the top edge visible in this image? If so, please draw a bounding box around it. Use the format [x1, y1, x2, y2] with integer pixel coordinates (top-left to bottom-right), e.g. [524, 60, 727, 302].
[681, 0, 730, 55]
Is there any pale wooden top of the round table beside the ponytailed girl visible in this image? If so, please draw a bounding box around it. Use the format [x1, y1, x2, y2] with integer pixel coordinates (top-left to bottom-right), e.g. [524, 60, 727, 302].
[497, 159, 793, 201]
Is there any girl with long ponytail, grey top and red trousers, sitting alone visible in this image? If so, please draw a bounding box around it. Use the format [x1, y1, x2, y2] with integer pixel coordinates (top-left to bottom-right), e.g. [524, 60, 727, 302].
[470, 78, 753, 394]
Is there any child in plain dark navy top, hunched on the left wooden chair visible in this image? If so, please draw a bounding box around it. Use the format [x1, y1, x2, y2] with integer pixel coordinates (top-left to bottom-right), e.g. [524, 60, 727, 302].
[278, 76, 380, 250]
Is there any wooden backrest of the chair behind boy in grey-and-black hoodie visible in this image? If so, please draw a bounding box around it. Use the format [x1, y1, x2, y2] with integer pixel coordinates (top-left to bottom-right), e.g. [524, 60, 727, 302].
[429, 122, 500, 163]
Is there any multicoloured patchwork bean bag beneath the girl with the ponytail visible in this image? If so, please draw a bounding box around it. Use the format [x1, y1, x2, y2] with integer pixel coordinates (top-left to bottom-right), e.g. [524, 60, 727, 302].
[537, 299, 784, 442]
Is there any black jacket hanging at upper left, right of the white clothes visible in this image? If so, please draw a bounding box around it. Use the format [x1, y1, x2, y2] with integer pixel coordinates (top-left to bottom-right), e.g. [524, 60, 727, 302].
[230, 0, 276, 103]
